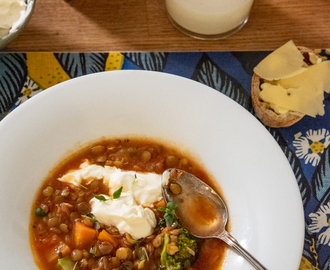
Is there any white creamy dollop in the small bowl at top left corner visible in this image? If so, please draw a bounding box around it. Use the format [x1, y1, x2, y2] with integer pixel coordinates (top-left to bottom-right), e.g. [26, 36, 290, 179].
[0, 0, 26, 38]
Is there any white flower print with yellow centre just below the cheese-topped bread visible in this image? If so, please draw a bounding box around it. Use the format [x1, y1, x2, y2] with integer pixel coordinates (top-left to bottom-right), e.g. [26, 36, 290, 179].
[293, 128, 330, 166]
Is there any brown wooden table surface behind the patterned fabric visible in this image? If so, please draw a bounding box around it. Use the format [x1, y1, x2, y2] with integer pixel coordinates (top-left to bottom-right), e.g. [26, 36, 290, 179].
[5, 0, 330, 52]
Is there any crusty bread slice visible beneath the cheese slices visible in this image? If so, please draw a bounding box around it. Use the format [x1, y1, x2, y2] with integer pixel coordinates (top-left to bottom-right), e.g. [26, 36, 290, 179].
[251, 46, 322, 128]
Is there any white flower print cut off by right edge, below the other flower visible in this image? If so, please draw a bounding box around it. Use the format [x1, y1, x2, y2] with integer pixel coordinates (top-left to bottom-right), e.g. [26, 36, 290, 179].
[308, 202, 330, 246]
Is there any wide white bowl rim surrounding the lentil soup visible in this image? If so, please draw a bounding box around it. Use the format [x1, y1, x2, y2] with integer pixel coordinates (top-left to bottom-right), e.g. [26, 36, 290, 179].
[0, 71, 304, 270]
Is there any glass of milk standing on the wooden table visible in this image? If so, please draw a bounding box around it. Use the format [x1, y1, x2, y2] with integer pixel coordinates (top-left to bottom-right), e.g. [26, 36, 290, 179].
[166, 0, 253, 39]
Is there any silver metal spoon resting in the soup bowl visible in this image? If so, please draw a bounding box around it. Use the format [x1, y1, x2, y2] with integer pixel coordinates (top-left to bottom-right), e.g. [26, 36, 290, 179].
[162, 169, 267, 270]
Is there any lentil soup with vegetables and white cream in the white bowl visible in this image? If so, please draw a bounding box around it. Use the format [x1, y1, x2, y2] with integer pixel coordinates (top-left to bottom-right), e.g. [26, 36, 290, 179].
[30, 138, 225, 270]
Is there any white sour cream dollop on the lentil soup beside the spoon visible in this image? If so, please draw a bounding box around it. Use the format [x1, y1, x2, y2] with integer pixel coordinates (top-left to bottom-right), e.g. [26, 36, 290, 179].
[58, 161, 162, 239]
